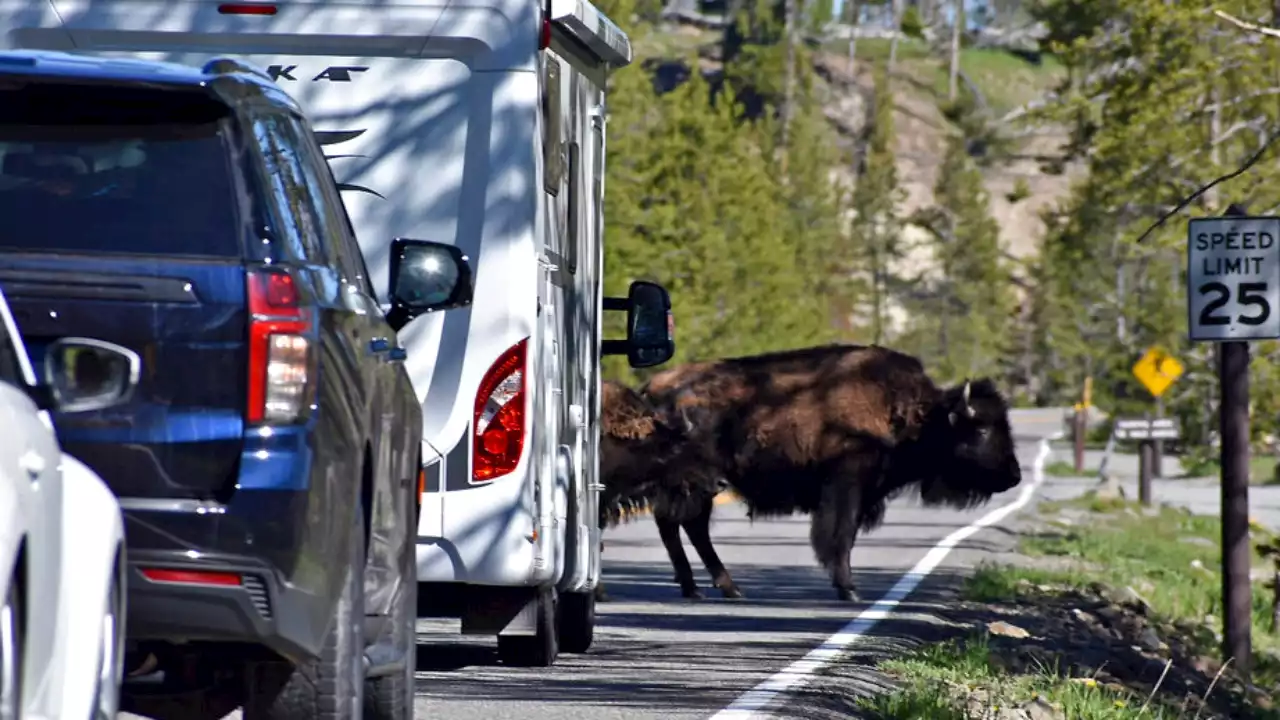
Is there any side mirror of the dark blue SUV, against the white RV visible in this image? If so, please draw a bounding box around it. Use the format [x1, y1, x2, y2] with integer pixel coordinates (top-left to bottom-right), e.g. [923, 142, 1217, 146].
[387, 237, 475, 331]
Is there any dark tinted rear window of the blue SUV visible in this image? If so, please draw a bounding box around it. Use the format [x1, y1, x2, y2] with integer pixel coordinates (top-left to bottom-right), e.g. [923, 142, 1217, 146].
[0, 81, 242, 256]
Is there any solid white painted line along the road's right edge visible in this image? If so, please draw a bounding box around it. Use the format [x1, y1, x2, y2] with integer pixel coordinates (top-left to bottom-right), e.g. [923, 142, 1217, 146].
[710, 433, 1062, 720]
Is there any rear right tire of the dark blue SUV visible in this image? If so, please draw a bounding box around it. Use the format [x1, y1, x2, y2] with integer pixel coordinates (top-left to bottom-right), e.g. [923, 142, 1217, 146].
[243, 505, 365, 720]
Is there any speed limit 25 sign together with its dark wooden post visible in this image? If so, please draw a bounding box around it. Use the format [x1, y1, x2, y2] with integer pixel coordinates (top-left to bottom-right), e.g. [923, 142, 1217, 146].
[1187, 204, 1280, 678]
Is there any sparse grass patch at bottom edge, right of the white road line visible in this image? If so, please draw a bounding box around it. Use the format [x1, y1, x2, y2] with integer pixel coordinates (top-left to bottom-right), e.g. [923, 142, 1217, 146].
[861, 634, 1174, 720]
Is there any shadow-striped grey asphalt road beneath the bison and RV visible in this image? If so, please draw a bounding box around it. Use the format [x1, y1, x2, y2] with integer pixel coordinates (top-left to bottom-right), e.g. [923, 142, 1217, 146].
[415, 411, 1060, 720]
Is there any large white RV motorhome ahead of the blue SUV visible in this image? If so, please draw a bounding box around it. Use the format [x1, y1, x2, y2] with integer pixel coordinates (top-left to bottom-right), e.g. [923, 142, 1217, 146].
[0, 0, 675, 665]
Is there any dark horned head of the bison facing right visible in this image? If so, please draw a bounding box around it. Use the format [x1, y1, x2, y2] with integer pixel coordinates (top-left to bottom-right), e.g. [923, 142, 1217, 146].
[920, 378, 1023, 507]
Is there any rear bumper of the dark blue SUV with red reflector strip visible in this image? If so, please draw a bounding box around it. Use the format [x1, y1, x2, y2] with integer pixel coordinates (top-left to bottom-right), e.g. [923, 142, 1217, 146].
[122, 489, 332, 661]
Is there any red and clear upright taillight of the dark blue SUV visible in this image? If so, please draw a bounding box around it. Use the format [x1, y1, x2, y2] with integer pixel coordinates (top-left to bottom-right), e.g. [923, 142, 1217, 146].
[246, 268, 315, 424]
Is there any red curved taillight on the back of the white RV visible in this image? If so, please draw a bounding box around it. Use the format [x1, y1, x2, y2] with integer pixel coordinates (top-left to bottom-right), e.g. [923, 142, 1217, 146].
[471, 338, 529, 483]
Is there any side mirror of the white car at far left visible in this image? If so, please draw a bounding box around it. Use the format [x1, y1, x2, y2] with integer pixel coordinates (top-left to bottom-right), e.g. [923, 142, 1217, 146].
[45, 337, 142, 413]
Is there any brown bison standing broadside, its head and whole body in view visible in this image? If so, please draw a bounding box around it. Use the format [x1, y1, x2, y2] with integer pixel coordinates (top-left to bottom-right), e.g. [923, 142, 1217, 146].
[634, 345, 1021, 600]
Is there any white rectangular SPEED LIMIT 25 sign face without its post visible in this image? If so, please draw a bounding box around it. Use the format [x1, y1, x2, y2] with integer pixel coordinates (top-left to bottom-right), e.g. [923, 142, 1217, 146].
[1187, 218, 1280, 341]
